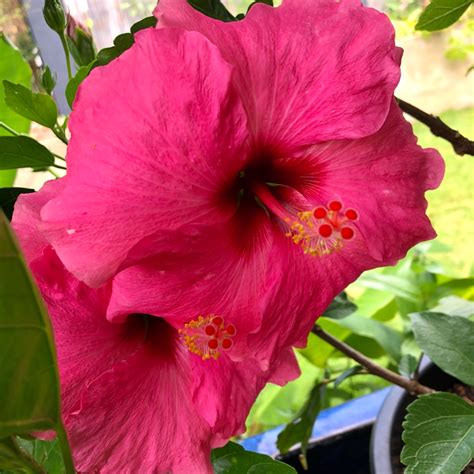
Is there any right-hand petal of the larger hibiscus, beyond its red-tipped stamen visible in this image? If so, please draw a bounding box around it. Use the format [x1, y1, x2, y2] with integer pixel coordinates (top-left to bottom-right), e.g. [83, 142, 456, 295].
[296, 101, 444, 266]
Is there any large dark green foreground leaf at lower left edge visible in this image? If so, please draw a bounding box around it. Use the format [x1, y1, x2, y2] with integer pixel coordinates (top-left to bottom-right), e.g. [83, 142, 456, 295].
[0, 212, 74, 473]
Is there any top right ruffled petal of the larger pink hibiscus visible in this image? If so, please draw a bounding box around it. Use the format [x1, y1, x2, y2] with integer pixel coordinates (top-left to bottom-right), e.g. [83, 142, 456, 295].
[154, 0, 401, 147]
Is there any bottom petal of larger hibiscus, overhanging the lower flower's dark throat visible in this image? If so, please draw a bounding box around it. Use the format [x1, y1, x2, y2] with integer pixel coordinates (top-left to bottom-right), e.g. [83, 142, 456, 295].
[108, 206, 281, 352]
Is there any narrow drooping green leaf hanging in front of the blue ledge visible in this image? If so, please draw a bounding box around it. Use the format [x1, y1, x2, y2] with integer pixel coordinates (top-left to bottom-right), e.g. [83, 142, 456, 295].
[277, 383, 326, 465]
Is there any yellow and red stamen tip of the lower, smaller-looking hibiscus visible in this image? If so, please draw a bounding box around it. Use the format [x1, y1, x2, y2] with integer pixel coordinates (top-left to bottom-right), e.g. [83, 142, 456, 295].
[179, 314, 237, 360]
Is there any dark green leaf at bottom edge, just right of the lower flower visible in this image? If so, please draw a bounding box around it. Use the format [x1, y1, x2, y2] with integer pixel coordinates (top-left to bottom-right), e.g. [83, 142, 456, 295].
[211, 441, 296, 474]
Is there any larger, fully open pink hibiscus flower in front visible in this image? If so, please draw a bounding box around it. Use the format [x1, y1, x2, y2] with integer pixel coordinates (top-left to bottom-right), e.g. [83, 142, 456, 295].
[36, 0, 443, 370]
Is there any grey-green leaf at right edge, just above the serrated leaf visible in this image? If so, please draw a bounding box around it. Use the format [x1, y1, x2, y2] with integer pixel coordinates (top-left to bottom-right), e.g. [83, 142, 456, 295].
[411, 312, 474, 385]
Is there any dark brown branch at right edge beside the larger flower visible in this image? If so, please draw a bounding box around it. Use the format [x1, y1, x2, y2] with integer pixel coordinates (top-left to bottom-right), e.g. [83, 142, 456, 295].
[397, 98, 474, 155]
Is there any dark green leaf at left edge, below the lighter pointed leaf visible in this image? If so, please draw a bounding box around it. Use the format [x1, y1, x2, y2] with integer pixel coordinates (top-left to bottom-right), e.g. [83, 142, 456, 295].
[0, 136, 54, 170]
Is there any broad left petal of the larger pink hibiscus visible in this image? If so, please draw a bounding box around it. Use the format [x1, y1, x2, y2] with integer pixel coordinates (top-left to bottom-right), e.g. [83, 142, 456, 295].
[41, 29, 246, 286]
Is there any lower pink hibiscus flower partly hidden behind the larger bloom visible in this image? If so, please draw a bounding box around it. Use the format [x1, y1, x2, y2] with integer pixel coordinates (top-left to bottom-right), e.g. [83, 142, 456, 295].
[13, 180, 296, 474]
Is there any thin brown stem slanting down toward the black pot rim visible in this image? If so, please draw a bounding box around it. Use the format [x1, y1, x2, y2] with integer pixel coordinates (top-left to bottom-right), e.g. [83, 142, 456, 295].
[312, 325, 434, 395]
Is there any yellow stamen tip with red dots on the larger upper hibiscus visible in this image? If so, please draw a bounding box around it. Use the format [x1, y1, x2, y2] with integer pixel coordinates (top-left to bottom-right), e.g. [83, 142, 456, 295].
[286, 200, 359, 257]
